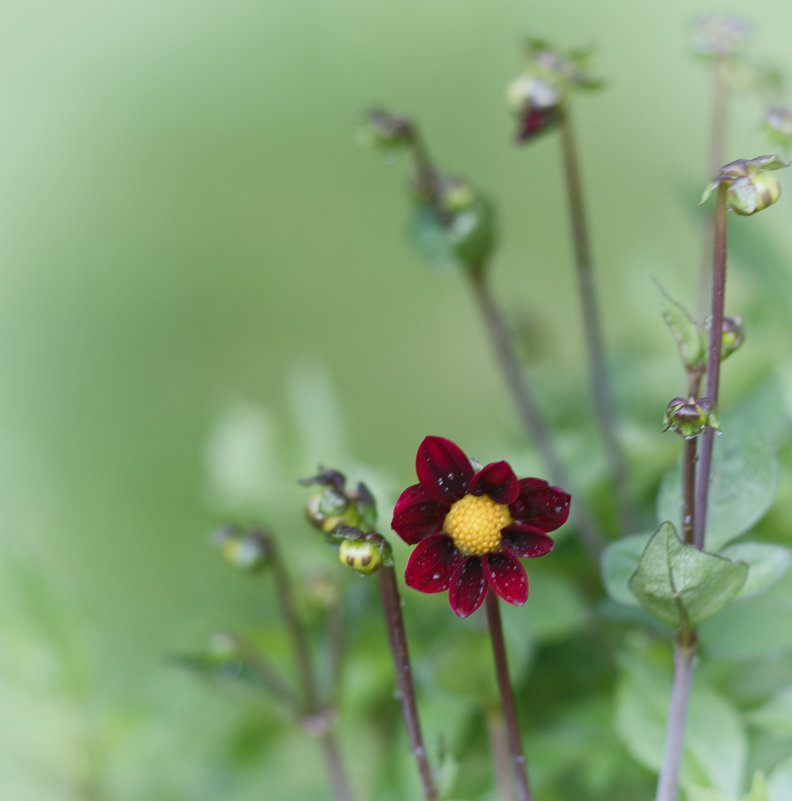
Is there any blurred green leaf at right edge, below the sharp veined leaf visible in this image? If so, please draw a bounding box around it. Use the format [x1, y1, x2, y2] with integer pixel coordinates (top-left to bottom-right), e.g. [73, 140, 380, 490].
[699, 571, 792, 659]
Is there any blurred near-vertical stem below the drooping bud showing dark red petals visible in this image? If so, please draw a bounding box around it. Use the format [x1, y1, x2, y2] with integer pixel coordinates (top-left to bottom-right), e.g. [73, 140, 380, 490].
[560, 114, 635, 533]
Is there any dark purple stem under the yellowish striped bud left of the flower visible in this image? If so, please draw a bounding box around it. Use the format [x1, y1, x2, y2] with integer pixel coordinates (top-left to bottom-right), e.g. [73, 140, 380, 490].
[377, 565, 437, 801]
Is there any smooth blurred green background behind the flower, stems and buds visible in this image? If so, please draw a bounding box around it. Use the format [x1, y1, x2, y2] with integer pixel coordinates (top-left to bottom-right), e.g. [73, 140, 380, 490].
[0, 0, 792, 801]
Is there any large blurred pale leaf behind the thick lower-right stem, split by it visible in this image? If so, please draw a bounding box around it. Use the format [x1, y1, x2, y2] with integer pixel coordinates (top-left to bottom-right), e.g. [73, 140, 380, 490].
[615, 649, 748, 798]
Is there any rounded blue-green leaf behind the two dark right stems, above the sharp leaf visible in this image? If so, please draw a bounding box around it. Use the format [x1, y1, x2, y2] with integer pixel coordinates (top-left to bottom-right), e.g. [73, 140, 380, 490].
[657, 432, 778, 551]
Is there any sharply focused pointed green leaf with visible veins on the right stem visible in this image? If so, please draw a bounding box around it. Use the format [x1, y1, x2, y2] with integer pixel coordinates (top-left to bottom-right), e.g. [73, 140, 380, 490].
[629, 522, 748, 628]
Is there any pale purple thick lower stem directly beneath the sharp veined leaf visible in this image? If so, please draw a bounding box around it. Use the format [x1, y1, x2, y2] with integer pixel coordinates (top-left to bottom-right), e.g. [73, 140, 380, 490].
[655, 630, 696, 801]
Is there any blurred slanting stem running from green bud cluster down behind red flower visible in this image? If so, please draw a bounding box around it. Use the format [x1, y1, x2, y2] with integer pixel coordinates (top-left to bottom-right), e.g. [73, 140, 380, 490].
[468, 270, 603, 558]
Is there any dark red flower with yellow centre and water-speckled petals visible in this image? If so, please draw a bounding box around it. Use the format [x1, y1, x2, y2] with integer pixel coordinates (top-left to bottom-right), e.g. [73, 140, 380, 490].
[391, 437, 570, 617]
